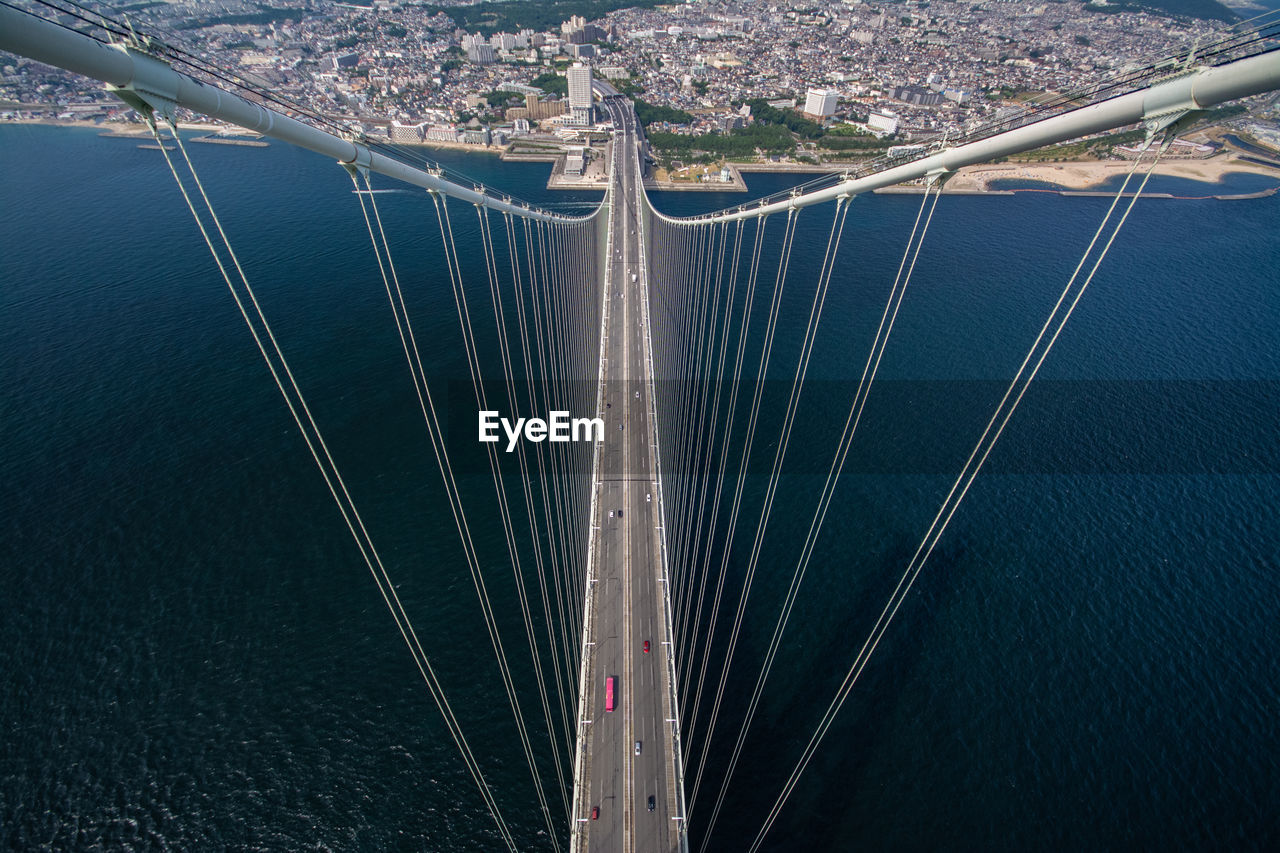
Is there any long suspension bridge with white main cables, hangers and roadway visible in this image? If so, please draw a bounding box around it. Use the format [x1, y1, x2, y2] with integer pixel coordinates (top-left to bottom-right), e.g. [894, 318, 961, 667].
[0, 0, 1280, 852]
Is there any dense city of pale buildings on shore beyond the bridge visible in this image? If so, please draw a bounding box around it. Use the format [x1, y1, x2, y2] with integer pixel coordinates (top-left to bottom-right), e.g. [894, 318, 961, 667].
[0, 0, 1268, 181]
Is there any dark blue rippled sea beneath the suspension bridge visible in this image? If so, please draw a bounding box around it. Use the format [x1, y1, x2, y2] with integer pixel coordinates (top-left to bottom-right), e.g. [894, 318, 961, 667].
[0, 127, 1280, 850]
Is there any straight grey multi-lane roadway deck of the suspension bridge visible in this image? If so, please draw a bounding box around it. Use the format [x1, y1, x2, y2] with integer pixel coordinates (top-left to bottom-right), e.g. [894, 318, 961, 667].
[572, 99, 685, 853]
